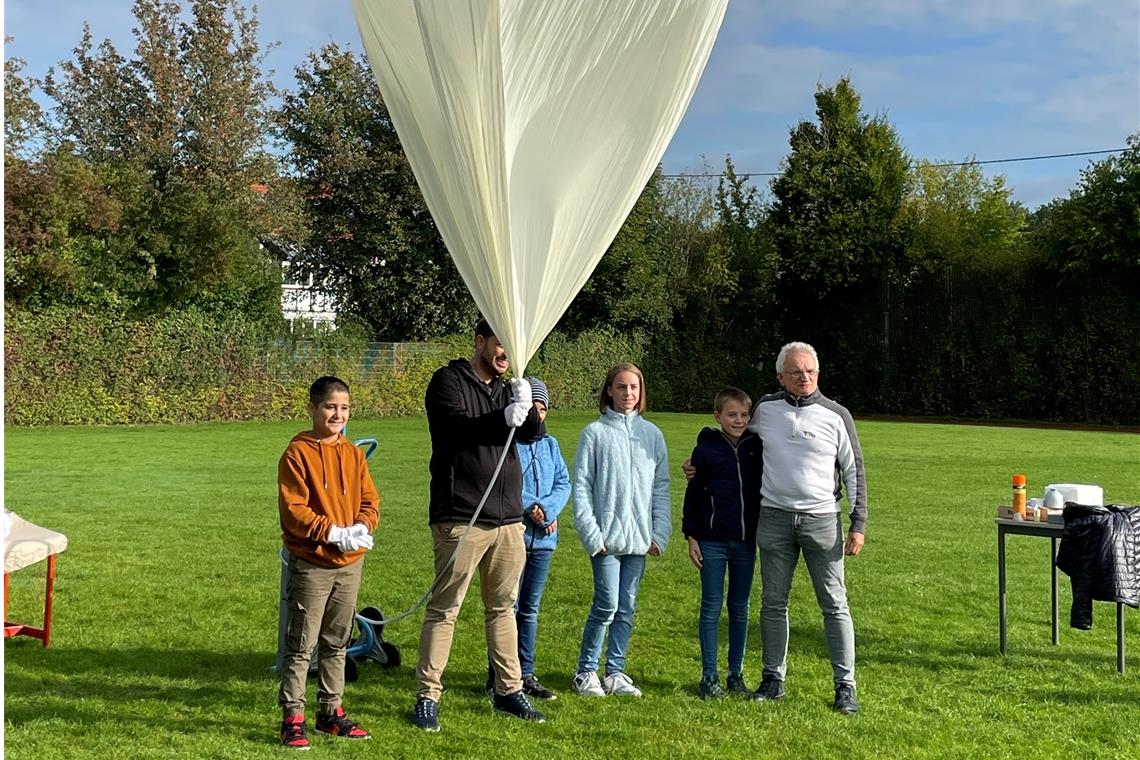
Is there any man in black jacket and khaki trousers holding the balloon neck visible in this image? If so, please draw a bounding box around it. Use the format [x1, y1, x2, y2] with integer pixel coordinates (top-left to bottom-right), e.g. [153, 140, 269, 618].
[412, 320, 544, 732]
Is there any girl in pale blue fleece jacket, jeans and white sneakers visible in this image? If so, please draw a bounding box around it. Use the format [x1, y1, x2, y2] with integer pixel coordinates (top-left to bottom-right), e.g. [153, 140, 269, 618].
[573, 362, 673, 696]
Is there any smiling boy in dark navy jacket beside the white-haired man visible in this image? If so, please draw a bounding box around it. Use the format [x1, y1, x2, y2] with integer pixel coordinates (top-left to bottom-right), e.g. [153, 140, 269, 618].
[682, 387, 762, 698]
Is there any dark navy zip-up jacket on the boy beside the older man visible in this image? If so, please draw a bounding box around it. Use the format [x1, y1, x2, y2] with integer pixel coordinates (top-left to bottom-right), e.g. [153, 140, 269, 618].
[681, 427, 763, 544]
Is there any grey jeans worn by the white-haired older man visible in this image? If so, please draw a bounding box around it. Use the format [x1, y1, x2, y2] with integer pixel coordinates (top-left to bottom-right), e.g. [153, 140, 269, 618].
[756, 507, 855, 686]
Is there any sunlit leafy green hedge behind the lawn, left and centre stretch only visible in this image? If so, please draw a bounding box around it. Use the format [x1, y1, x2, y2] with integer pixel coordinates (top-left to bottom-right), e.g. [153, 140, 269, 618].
[5, 309, 643, 425]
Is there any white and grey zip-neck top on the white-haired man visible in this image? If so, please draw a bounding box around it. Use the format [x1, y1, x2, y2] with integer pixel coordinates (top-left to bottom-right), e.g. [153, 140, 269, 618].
[748, 391, 866, 533]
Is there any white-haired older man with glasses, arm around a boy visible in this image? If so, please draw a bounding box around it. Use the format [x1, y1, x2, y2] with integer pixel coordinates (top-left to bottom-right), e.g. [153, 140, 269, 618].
[748, 343, 866, 714]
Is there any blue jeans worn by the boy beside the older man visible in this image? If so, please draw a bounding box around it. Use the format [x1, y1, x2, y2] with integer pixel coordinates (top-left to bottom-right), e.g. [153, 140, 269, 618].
[697, 541, 756, 678]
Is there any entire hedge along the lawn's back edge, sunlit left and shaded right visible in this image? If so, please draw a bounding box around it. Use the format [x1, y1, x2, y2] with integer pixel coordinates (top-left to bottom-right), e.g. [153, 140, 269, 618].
[5, 276, 1140, 426]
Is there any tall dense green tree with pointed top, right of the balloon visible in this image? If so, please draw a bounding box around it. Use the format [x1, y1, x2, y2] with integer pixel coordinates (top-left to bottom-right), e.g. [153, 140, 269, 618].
[771, 77, 909, 292]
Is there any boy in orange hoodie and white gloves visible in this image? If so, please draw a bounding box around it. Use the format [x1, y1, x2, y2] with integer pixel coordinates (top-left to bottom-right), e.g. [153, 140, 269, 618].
[277, 376, 380, 750]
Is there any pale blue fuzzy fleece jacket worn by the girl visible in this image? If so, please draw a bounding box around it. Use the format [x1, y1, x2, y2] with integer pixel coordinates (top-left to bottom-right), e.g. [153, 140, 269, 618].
[573, 409, 673, 557]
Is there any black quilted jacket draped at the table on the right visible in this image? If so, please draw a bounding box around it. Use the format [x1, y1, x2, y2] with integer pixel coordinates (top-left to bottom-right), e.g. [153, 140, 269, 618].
[1057, 501, 1140, 630]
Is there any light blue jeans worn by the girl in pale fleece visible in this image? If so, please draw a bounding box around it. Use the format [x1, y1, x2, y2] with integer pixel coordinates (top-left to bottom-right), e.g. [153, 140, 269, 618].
[578, 554, 645, 676]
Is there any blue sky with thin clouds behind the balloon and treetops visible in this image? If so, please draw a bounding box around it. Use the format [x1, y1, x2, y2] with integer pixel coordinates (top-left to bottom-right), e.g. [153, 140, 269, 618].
[3, 0, 1140, 207]
